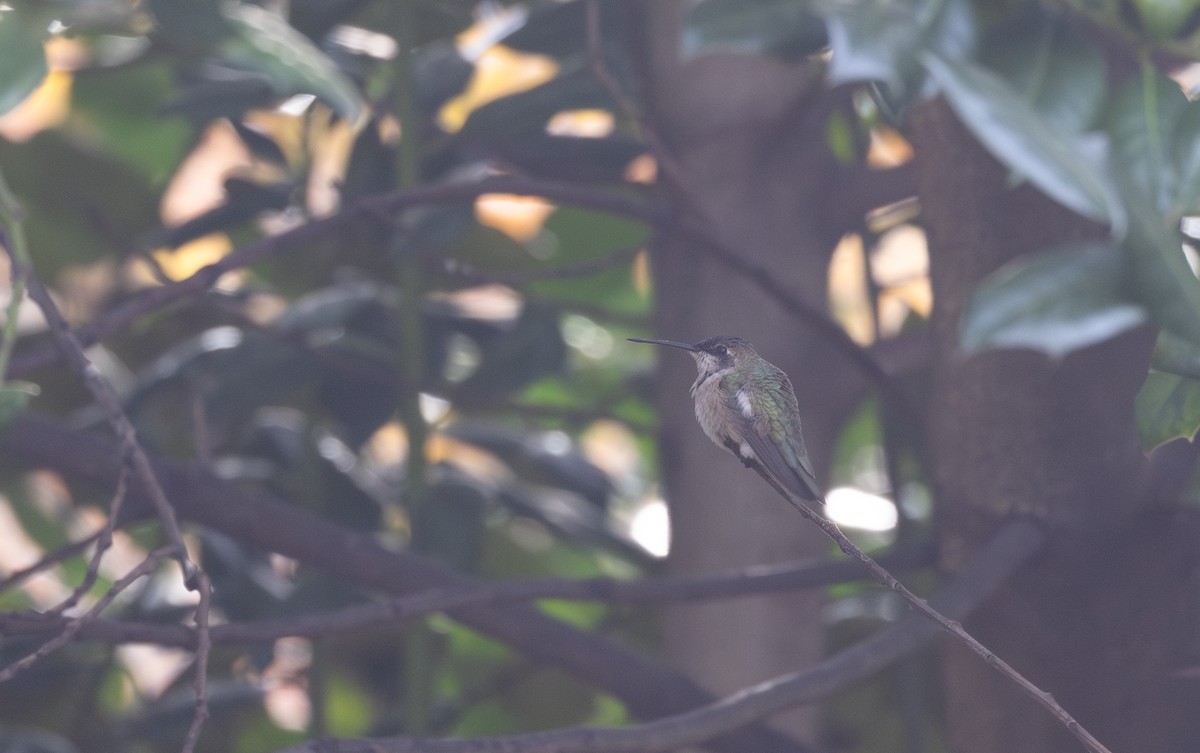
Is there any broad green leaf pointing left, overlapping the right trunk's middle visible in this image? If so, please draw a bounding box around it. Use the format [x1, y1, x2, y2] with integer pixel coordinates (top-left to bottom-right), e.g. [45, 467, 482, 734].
[961, 242, 1146, 357]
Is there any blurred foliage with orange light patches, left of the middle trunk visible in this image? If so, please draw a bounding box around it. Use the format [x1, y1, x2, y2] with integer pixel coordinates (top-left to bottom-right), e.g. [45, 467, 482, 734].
[0, 0, 654, 752]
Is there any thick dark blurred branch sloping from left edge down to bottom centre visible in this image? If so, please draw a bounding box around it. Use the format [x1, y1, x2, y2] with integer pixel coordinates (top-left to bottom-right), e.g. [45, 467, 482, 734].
[0, 415, 799, 753]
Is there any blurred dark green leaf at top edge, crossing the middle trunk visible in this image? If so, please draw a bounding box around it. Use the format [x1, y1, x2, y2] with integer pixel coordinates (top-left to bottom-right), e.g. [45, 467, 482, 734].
[680, 0, 828, 58]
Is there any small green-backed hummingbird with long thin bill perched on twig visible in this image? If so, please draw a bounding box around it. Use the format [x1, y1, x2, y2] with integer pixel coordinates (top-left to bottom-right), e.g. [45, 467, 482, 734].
[629, 335, 824, 505]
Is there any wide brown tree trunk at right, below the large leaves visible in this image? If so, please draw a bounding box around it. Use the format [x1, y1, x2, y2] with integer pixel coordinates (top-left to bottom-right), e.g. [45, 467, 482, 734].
[913, 101, 1200, 753]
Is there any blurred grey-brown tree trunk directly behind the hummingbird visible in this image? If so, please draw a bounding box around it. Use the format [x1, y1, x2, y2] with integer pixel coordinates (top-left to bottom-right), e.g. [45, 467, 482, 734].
[644, 2, 862, 739]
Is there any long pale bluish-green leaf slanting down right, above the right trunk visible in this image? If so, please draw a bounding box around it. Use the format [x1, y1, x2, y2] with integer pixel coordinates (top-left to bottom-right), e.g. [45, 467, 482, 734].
[922, 53, 1127, 236]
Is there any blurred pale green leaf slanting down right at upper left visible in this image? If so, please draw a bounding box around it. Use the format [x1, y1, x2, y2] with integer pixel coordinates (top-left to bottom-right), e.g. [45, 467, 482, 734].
[217, 4, 362, 122]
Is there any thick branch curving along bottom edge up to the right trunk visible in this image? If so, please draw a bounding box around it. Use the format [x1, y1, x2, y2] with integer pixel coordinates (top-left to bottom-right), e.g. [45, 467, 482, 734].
[270, 520, 1045, 753]
